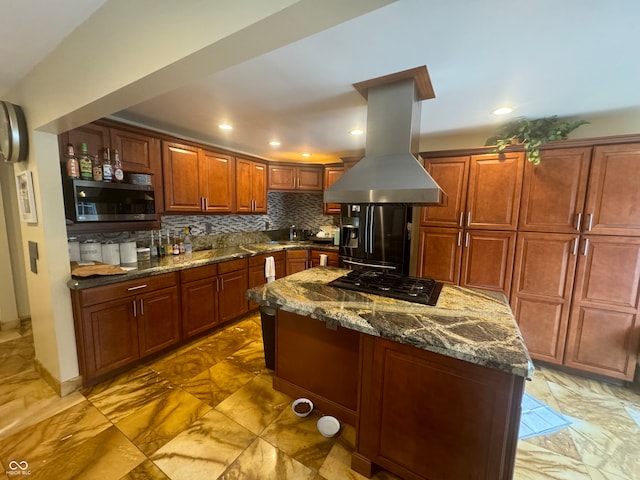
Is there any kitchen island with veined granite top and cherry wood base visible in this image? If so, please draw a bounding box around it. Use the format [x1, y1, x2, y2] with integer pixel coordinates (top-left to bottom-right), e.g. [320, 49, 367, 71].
[247, 267, 533, 480]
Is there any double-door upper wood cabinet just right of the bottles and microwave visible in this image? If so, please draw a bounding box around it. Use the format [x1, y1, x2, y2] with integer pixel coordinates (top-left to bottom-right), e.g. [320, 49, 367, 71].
[162, 142, 235, 213]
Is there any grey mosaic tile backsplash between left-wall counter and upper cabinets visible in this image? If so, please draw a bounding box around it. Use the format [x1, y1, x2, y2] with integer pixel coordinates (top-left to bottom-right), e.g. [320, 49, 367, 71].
[70, 192, 339, 250]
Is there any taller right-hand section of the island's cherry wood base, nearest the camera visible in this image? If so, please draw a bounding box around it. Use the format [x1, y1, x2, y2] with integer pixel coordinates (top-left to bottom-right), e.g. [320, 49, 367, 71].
[351, 335, 524, 480]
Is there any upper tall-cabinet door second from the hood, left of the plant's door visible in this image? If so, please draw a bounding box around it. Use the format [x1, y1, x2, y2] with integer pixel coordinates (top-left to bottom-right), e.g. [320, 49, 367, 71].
[465, 152, 524, 230]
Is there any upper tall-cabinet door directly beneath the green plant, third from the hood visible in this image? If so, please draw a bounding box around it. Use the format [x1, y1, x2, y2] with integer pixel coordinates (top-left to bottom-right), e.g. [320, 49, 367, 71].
[518, 147, 591, 233]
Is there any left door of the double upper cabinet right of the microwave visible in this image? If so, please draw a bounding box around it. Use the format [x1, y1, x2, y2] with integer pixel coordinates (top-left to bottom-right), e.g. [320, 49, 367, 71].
[162, 142, 202, 212]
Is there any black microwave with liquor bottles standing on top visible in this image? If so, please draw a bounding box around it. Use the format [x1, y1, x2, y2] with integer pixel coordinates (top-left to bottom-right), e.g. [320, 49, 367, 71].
[65, 179, 158, 223]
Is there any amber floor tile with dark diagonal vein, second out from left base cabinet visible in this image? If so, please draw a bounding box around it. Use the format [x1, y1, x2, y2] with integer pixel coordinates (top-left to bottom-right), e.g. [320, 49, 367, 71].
[116, 390, 211, 455]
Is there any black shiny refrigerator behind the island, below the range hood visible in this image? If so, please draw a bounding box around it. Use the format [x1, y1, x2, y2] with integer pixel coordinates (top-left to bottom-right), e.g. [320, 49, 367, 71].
[340, 204, 411, 274]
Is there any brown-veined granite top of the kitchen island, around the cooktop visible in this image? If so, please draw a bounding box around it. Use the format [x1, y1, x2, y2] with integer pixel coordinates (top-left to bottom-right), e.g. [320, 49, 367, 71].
[247, 267, 534, 379]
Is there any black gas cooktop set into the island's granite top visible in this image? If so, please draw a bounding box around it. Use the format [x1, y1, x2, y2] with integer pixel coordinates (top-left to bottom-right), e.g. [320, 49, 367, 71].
[329, 269, 442, 306]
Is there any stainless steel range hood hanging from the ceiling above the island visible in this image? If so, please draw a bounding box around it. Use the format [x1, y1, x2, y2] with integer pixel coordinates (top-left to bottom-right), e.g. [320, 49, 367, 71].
[324, 66, 447, 206]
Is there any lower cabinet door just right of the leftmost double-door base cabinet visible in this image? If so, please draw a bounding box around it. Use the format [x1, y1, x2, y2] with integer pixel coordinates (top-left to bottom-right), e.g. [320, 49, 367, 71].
[181, 277, 218, 338]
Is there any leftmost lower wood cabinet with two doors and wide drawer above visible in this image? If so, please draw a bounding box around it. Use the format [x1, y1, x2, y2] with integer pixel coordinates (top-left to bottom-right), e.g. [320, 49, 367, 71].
[71, 273, 181, 385]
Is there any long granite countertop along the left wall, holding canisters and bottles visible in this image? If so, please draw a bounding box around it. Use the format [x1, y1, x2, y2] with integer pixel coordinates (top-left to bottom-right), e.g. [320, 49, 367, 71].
[67, 241, 338, 290]
